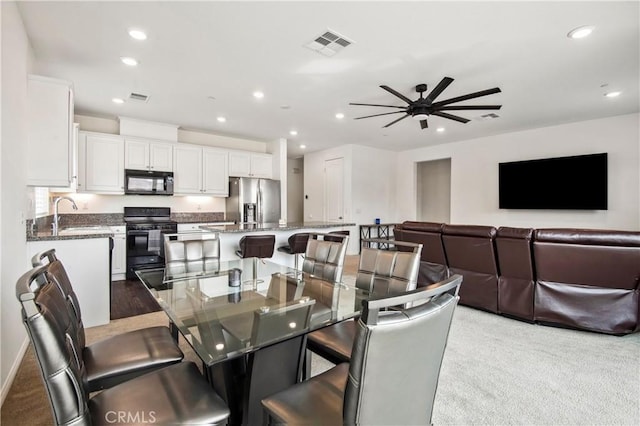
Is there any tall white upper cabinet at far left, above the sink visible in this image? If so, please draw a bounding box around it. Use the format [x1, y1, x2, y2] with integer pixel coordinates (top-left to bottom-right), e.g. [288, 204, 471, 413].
[27, 75, 74, 187]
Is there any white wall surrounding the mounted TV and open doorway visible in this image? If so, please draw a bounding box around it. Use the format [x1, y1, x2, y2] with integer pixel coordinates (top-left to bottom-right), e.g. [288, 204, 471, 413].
[396, 114, 640, 230]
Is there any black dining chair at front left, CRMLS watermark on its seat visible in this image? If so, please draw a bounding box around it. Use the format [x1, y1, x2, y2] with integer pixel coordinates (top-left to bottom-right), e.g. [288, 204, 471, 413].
[16, 264, 229, 425]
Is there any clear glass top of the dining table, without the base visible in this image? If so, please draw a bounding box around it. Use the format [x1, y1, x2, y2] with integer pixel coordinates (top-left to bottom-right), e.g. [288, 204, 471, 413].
[136, 258, 368, 365]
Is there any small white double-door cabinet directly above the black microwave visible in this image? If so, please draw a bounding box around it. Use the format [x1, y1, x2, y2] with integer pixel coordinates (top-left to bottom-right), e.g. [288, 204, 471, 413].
[124, 136, 175, 172]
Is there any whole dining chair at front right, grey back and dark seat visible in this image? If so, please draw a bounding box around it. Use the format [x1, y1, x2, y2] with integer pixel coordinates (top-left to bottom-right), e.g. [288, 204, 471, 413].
[262, 275, 462, 425]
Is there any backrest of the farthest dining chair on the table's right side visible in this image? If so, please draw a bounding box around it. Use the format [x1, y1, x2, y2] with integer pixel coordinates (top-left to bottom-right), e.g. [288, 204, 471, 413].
[302, 234, 349, 282]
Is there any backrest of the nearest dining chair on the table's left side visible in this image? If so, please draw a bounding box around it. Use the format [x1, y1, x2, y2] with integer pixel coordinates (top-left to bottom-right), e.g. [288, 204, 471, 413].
[16, 265, 91, 425]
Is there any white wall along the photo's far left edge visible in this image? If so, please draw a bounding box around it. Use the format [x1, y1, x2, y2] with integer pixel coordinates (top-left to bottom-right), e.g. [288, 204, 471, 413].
[0, 2, 33, 401]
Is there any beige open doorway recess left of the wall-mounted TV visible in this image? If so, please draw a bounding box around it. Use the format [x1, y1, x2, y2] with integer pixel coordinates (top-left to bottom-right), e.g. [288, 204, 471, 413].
[416, 158, 451, 223]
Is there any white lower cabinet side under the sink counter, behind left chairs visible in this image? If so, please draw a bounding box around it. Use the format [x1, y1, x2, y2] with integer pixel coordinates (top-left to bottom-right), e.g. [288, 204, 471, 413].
[25, 238, 111, 327]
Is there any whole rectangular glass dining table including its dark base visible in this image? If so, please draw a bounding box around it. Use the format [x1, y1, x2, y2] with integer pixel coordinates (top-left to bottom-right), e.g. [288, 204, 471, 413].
[136, 258, 368, 424]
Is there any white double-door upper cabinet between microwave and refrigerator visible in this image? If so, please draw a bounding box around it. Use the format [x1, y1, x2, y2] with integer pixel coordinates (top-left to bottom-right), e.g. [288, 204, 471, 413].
[173, 144, 229, 197]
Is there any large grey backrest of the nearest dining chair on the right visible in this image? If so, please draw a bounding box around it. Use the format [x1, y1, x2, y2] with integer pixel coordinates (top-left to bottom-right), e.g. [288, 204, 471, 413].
[343, 275, 462, 424]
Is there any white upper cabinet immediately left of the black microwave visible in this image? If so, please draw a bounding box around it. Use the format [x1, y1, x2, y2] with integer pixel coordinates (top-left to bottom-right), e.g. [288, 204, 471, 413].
[78, 132, 124, 194]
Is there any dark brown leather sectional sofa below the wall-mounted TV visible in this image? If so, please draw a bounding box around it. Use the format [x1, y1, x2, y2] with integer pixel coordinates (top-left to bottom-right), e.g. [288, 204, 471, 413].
[394, 221, 640, 334]
